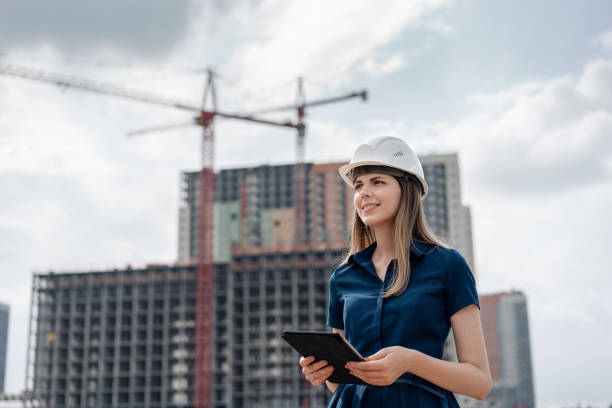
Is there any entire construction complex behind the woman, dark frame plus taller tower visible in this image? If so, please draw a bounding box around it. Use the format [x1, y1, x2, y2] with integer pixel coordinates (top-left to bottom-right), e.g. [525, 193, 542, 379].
[27, 155, 472, 408]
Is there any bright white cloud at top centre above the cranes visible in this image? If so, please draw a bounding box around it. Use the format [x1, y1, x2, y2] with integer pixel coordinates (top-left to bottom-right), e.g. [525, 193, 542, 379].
[223, 0, 446, 107]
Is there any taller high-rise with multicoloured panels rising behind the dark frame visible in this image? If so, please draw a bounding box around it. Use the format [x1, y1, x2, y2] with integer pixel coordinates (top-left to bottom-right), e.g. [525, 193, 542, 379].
[178, 154, 475, 274]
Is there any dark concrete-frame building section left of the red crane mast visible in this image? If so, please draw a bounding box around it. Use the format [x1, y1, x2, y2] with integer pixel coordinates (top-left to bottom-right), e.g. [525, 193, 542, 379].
[26, 265, 201, 407]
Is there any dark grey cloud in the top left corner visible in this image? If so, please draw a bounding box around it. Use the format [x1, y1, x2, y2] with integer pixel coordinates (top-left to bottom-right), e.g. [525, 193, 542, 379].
[0, 0, 197, 58]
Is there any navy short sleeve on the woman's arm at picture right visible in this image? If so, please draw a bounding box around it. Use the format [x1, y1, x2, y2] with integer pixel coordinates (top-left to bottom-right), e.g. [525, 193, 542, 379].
[444, 251, 480, 319]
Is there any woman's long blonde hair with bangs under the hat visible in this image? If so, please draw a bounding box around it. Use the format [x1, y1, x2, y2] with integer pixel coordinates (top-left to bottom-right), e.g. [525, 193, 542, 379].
[342, 166, 447, 297]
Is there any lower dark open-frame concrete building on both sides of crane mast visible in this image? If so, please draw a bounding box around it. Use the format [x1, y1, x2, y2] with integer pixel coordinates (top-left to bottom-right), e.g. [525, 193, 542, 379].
[28, 245, 346, 408]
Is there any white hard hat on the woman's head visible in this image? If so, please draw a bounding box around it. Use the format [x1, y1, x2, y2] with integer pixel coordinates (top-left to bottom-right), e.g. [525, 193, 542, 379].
[338, 136, 429, 199]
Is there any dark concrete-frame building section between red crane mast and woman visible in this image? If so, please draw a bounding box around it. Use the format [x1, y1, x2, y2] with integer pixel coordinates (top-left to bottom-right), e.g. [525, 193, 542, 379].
[225, 245, 347, 408]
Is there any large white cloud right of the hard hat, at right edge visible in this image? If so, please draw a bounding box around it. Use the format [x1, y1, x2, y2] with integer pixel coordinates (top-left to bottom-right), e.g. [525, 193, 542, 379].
[416, 60, 612, 195]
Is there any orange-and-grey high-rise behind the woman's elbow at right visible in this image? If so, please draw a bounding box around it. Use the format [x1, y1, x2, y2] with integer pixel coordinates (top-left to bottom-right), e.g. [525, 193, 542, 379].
[459, 292, 535, 408]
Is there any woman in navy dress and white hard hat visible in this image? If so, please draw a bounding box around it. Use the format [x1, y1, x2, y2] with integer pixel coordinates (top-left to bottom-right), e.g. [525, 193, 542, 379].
[300, 137, 491, 408]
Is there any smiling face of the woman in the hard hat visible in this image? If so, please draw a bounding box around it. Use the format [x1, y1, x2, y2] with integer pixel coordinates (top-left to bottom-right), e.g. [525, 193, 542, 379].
[353, 173, 402, 227]
